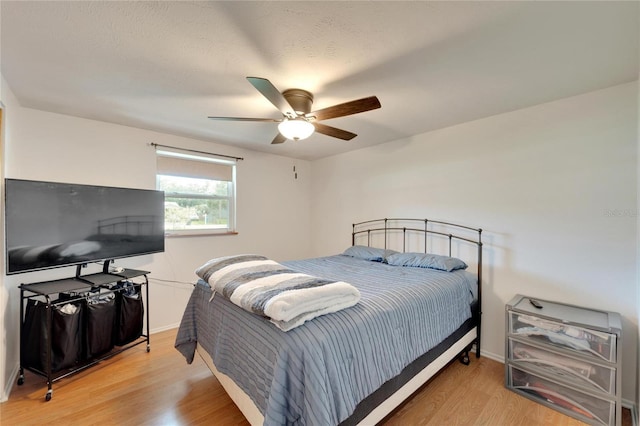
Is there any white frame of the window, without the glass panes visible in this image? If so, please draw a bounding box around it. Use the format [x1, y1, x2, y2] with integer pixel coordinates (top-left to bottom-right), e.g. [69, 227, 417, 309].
[156, 149, 238, 237]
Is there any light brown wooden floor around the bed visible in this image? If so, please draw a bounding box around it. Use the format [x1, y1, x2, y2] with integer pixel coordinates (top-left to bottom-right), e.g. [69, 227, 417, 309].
[0, 330, 631, 426]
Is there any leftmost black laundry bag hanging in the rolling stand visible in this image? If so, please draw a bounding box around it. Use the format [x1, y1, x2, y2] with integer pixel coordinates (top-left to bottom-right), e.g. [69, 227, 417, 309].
[20, 299, 83, 372]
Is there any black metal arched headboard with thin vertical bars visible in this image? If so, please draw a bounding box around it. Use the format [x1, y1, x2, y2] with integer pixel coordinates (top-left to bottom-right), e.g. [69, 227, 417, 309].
[351, 218, 482, 357]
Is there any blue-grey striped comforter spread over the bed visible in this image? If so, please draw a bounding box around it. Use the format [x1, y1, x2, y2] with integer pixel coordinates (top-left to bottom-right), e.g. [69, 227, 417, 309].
[176, 255, 475, 425]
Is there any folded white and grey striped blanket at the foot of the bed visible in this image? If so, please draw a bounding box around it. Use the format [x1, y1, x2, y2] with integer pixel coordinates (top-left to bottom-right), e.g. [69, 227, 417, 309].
[196, 255, 360, 331]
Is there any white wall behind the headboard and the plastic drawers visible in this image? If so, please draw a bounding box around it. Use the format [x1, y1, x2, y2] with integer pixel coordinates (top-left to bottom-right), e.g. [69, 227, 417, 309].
[311, 83, 638, 402]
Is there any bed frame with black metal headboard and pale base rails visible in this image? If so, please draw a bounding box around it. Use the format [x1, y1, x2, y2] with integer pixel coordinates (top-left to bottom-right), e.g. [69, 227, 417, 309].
[198, 218, 482, 426]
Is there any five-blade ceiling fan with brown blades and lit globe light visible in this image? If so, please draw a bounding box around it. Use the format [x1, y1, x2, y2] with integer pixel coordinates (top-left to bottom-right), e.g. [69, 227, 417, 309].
[209, 77, 381, 144]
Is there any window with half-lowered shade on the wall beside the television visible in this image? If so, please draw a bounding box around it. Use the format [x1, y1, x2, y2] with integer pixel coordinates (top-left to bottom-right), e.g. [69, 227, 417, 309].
[156, 150, 236, 235]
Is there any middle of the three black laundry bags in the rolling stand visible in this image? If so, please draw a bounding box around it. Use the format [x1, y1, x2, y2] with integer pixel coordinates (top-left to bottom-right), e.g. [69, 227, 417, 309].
[86, 298, 116, 358]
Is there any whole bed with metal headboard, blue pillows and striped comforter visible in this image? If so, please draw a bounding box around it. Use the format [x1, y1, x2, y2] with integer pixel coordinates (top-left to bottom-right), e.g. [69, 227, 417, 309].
[176, 218, 482, 425]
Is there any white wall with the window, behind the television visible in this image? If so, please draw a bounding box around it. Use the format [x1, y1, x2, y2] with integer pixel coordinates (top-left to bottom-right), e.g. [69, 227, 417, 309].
[0, 89, 311, 400]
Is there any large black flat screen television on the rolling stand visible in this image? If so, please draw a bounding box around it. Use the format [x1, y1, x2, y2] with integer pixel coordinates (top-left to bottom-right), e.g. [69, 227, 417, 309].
[5, 179, 164, 275]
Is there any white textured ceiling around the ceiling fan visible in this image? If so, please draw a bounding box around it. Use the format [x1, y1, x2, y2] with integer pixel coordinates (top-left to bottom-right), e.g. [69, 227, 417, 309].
[0, 0, 640, 159]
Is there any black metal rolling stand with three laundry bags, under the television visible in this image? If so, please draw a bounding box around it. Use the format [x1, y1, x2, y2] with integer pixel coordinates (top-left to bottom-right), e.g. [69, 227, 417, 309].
[18, 262, 151, 401]
